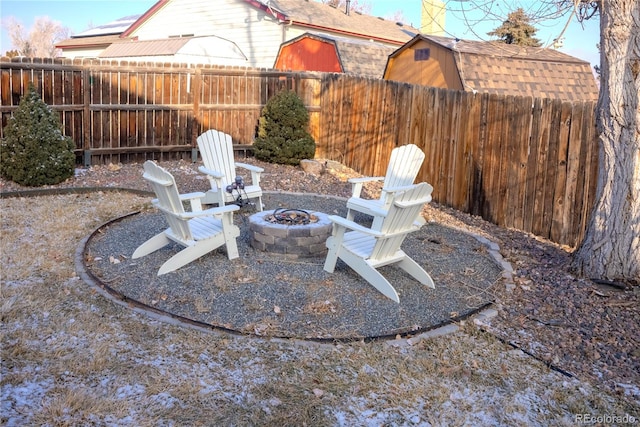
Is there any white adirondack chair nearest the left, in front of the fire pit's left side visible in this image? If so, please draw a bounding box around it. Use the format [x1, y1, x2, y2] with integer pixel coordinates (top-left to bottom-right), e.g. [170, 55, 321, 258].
[132, 160, 240, 276]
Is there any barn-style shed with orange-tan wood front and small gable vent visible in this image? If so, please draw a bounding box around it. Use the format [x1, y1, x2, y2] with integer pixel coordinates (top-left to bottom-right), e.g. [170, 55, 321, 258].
[384, 34, 598, 101]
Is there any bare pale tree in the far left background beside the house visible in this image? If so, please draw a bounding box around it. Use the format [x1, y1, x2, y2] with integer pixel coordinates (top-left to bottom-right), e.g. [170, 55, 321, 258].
[2, 16, 71, 58]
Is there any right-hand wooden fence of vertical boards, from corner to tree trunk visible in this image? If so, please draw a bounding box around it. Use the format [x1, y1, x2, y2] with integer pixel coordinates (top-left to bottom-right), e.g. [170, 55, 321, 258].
[316, 75, 598, 246]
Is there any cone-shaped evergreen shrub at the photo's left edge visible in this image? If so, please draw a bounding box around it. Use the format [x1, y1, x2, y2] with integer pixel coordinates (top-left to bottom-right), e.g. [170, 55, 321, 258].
[0, 84, 75, 187]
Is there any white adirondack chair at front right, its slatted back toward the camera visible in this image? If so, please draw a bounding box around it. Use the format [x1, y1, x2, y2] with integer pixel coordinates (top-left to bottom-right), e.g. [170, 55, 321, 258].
[324, 182, 435, 303]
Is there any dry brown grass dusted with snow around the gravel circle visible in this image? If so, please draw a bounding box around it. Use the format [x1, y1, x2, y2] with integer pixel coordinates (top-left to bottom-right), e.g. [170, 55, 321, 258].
[0, 193, 637, 426]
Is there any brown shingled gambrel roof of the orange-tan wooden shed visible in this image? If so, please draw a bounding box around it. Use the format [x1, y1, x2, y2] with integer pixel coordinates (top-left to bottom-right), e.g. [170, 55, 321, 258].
[390, 35, 598, 101]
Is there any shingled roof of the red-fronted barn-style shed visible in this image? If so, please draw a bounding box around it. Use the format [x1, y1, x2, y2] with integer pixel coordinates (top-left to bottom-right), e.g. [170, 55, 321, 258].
[276, 33, 395, 78]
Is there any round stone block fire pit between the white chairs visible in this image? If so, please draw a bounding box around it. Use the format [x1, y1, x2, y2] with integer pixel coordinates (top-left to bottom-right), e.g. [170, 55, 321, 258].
[249, 209, 333, 259]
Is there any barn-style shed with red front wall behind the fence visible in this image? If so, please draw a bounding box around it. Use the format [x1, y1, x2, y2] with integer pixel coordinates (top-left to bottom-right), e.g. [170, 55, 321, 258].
[273, 33, 396, 79]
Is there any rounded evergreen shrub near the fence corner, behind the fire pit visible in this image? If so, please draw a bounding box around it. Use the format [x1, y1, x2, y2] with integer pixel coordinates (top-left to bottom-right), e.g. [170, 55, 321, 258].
[253, 90, 316, 165]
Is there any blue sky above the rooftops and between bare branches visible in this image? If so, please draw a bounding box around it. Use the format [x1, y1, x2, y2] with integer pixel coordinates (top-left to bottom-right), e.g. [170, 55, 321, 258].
[0, 0, 600, 65]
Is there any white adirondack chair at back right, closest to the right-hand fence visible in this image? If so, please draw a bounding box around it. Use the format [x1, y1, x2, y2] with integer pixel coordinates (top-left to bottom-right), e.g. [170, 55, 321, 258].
[347, 144, 424, 230]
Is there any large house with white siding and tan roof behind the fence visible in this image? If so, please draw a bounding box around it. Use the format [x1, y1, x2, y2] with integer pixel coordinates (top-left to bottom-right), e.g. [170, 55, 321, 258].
[56, 0, 419, 68]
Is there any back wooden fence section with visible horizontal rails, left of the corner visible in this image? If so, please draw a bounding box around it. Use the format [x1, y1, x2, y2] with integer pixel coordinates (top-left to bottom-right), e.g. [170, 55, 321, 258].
[0, 58, 320, 165]
